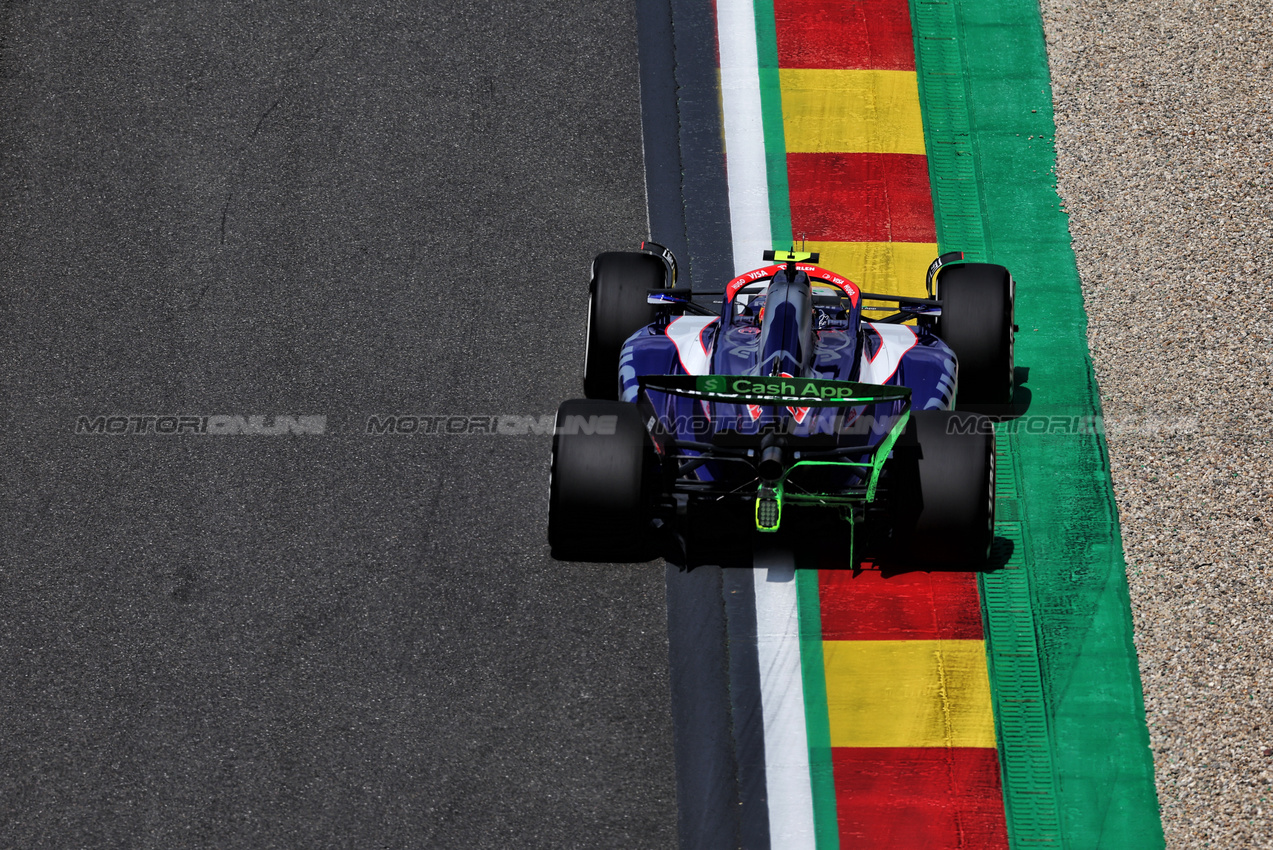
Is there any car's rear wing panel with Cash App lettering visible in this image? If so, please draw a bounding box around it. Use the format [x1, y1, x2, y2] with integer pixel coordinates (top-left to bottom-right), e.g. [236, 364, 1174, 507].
[638, 375, 910, 407]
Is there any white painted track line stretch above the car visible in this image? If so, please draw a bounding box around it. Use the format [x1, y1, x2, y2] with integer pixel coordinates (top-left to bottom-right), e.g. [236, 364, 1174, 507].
[717, 0, 774, 275]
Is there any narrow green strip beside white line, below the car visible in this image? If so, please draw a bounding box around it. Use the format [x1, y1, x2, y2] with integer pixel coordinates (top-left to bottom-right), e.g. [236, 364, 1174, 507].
[796, 565, 840, 850]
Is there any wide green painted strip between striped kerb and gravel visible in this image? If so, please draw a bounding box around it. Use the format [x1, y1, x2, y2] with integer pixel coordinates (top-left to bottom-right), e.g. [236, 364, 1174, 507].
[911, 0, 1164, 850]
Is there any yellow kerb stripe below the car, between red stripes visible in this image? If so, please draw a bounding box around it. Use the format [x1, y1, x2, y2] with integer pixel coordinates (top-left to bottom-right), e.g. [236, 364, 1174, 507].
[822, 640, 995, 747]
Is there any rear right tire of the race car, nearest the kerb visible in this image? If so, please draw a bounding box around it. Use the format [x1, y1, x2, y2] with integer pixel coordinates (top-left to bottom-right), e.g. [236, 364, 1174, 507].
[889, 410, 994, 569]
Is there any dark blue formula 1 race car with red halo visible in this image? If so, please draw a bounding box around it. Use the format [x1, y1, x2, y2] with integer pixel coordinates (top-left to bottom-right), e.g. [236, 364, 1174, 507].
[549, 242, 1016, 568]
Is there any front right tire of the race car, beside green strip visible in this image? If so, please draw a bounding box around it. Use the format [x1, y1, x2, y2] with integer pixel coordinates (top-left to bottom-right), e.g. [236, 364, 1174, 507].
[936, 262, 1015, 410]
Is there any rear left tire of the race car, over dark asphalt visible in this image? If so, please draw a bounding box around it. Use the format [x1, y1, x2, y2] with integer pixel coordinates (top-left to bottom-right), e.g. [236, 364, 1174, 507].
[549, 398, 654, 562]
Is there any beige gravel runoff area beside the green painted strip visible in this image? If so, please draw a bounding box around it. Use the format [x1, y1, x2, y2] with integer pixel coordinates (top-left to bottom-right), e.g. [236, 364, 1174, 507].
[1041, 0, 1273, 847]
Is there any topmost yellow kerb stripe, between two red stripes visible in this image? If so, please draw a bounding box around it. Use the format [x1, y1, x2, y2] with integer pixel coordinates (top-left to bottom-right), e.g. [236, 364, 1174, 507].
[779, 69, 924, 154]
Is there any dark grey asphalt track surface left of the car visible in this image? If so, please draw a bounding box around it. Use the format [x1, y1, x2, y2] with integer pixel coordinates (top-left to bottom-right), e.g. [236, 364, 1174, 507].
[0, 0, 676, 847]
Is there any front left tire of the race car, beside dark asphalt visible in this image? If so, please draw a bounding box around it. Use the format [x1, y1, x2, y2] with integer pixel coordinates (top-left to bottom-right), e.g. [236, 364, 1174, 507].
[583, 251, 667, 401]
